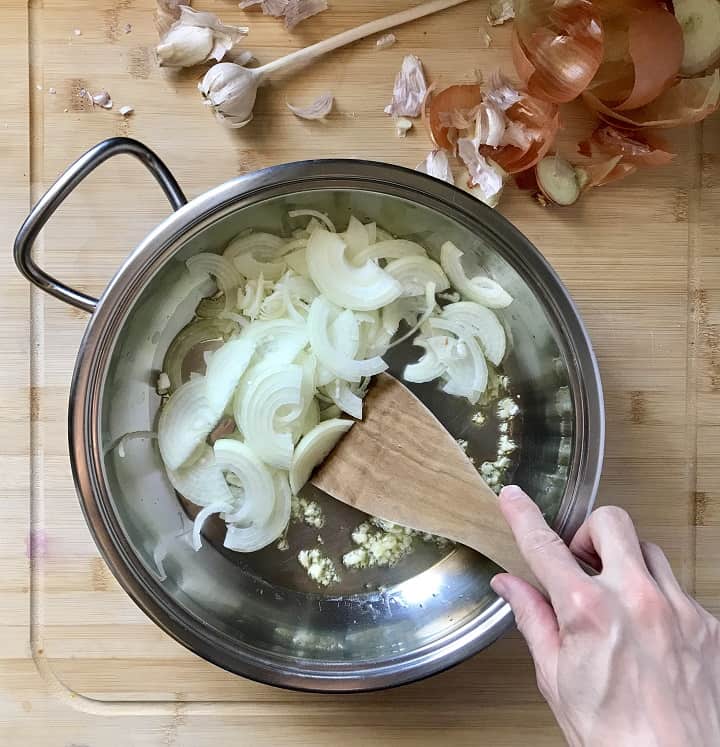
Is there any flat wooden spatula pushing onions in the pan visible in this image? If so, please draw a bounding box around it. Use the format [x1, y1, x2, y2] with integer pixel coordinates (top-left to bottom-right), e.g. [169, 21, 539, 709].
[311, 374, 541, 588]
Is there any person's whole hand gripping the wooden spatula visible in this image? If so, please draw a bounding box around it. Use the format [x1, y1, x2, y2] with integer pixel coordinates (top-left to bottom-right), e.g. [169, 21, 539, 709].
[492, 486, 720, 747]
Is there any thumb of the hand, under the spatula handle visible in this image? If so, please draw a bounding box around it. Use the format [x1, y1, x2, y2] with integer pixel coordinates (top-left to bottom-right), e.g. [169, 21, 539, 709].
[490, 573, 560, 683]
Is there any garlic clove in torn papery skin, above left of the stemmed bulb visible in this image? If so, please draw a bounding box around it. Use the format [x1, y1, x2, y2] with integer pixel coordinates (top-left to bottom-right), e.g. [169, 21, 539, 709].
[155, 5, 248, 68]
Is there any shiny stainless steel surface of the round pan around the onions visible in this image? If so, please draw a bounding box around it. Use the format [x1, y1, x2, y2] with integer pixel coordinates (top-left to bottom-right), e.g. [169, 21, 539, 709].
[18, 139, 604, 691]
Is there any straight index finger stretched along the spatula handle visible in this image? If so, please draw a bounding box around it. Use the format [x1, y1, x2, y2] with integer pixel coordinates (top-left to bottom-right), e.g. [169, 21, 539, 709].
[500, 485, 584, 600]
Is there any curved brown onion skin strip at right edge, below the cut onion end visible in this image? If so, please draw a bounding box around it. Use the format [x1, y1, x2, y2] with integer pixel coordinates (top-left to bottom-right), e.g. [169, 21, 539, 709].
[583, 70, 720, 129]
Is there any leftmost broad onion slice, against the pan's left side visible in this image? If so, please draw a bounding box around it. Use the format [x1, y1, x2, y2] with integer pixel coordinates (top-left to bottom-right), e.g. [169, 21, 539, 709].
[158, 376, 215, 470]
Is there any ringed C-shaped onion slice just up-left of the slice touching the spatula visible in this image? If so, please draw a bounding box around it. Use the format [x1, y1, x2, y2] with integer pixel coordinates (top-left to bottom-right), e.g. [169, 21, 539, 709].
[234, 364, 302, 469]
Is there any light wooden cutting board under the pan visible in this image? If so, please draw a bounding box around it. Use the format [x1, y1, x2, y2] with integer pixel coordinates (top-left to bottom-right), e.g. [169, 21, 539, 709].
[0, 0, 720, 747]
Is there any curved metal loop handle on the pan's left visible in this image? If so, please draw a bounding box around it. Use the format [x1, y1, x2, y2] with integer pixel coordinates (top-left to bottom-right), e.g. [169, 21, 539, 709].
[13, 137, 187, 313]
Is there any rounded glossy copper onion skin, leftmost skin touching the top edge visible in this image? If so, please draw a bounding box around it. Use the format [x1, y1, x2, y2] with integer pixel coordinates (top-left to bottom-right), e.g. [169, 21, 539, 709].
[513, 0, 603, 104]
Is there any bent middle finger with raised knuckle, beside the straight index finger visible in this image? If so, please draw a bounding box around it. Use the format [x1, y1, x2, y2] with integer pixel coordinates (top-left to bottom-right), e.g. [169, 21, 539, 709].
[570, 506, 645, 576]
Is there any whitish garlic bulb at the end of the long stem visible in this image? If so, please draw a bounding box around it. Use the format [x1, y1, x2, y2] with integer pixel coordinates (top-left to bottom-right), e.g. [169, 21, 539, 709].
[198, 62, 262, 128]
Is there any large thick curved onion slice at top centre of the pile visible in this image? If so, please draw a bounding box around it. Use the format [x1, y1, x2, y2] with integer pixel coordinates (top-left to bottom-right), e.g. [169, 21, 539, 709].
[307, 229, 402, 311]
